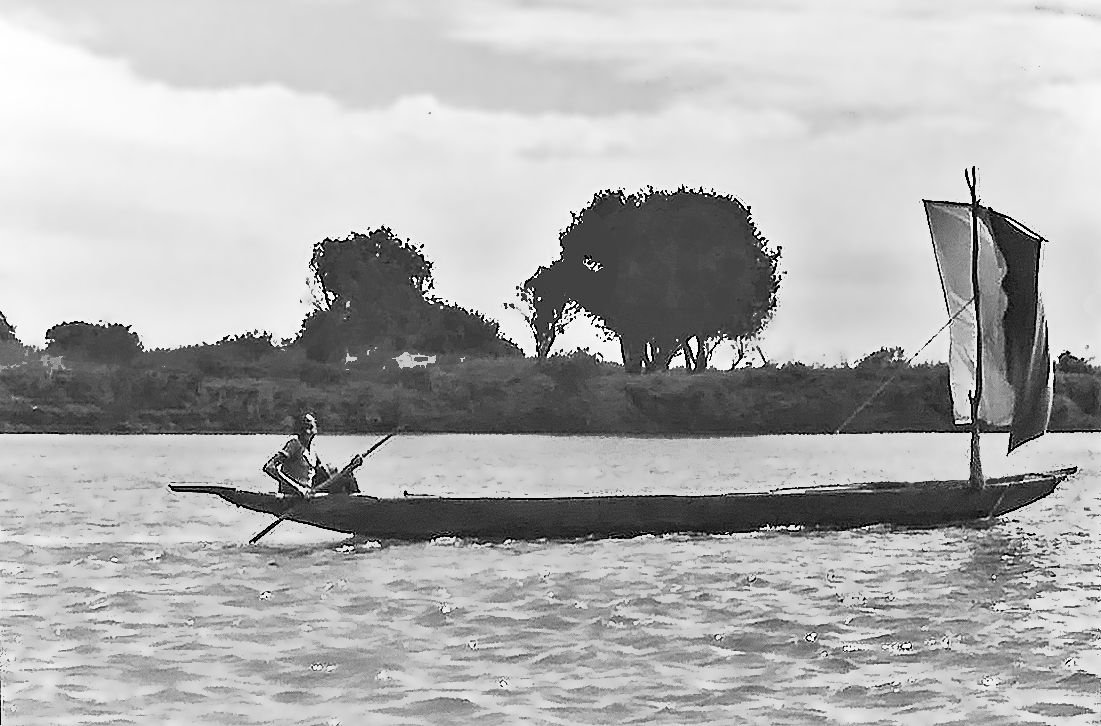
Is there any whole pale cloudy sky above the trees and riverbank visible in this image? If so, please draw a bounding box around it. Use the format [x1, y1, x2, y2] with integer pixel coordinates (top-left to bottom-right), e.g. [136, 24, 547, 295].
[0, 0, 1101, 365]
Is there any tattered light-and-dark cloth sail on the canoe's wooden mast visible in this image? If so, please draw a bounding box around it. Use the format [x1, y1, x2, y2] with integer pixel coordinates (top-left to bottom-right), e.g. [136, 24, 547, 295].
[925, 201, 1053, 452]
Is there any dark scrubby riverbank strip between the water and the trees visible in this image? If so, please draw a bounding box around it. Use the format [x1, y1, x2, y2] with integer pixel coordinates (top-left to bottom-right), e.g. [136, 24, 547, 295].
[0, 350, 1101, 435]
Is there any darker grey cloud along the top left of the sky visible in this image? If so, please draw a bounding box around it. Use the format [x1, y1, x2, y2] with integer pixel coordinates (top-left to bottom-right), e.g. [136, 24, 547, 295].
[0, 0, 687, 115]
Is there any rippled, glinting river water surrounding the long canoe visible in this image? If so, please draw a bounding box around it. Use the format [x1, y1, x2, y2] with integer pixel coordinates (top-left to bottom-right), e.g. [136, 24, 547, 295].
[0, 435, 1101, 724]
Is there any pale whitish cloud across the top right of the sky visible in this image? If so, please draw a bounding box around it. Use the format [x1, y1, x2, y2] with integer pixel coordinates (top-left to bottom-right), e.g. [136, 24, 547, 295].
[456, 0, 1101, 126]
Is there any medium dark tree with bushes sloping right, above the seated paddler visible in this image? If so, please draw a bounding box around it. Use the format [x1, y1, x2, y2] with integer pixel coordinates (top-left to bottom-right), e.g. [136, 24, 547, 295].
[297, 227, 516, 360]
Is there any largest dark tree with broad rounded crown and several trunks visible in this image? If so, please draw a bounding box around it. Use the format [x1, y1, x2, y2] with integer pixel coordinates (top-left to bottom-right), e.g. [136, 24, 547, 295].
[528, 187, 781, 372]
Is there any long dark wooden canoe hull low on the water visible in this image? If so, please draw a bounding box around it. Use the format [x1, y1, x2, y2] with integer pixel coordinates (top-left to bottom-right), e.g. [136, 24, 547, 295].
[172, 467, 1077, 540]
